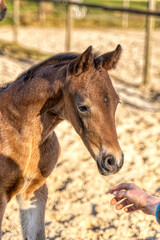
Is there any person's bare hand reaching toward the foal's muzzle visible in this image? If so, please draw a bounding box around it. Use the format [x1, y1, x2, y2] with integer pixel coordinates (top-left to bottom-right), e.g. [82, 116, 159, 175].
[110, 183, 160, 215]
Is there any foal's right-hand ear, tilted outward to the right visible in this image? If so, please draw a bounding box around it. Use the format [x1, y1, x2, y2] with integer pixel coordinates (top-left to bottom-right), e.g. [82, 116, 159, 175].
[96, 45, 122, 70]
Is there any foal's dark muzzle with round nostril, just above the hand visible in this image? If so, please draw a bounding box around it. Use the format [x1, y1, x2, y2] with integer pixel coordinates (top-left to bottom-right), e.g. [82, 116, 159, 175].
[97, 154, 124, 176]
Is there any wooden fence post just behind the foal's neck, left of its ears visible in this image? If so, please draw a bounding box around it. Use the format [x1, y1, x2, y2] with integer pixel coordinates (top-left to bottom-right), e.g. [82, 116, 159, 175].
[65, 0, 73, 52]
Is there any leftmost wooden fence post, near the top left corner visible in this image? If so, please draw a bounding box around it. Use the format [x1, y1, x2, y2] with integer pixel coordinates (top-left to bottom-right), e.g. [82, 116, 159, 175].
[13, 0, 19, 42]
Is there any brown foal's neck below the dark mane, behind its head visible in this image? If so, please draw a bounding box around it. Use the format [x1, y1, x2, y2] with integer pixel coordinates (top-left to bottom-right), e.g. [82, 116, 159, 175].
[0, 66, 66, 140]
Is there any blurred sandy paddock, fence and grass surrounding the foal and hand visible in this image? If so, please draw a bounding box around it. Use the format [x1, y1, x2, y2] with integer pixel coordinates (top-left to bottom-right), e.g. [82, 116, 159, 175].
[0, 0, 160, 240]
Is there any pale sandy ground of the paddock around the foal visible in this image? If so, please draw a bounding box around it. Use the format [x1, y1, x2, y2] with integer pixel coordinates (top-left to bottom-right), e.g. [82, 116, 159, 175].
[0, 27, 160, 240]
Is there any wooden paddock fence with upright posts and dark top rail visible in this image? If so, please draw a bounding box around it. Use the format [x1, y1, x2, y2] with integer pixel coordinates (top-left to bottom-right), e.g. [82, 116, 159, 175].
[13, 0, 160, 85]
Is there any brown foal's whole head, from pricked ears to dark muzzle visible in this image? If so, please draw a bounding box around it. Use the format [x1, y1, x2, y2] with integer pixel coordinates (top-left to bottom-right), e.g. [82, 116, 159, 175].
[64, 45, 123, 175]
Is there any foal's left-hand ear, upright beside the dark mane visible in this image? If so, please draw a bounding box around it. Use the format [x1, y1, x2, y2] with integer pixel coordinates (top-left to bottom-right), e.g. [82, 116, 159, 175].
[69, 46, 94, 75]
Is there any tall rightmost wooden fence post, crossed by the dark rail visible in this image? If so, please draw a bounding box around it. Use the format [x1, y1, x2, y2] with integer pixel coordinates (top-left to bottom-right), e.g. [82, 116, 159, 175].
[143, 0, 155, 85]
